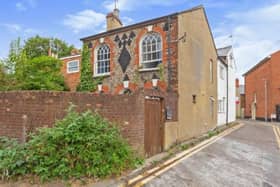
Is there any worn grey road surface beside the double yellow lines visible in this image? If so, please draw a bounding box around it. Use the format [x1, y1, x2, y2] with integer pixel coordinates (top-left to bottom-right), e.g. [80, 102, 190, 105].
[145, 121, 280, 187]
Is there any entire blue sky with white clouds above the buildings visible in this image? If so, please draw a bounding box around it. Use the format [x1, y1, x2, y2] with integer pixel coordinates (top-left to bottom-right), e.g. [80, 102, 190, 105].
[0, 0, 280, 82]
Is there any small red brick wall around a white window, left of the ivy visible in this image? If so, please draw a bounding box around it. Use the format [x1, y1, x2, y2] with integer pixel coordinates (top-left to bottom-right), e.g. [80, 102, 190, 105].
[61, 56, 81, 91]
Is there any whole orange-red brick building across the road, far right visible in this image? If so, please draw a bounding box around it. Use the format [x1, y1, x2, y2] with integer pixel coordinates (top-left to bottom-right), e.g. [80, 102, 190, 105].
[244, 51, 280, 121]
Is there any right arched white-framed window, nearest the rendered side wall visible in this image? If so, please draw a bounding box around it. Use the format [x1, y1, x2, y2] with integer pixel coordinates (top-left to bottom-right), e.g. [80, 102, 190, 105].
[140, 33, 162, 69]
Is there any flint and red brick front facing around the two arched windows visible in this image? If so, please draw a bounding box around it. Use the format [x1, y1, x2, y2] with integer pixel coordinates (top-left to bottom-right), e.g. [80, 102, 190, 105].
[86, 18, 178, 94]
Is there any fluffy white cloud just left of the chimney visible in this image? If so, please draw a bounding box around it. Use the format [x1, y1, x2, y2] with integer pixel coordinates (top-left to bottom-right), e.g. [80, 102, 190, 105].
[63, 10, 106, 33]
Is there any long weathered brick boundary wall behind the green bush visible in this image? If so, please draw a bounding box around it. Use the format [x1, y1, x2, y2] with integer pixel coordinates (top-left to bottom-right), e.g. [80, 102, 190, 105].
[0, 91, 145, 153]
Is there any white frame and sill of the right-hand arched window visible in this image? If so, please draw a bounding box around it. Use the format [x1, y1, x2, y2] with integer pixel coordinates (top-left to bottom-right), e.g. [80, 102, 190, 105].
[139, 32, 163, 71]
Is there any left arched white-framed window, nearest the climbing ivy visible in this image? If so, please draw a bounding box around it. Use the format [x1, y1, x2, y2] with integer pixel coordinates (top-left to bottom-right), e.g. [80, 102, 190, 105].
[94, 45, 110, 76]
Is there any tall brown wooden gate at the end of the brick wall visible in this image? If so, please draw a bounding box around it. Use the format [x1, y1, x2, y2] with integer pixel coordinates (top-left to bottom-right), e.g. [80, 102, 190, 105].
[145, 97, 165, 156]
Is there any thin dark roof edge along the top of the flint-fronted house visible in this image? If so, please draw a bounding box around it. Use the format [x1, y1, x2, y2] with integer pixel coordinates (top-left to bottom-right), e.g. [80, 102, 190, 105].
[80, 5, 205, 41]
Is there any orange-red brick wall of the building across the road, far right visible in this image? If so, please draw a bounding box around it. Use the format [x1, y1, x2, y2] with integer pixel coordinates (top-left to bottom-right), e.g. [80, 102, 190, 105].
[245, 51, 280, 119]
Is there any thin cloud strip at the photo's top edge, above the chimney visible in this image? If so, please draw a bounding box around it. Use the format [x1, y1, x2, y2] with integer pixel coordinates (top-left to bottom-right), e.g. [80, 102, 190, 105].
[103, 0, 187, 11]
